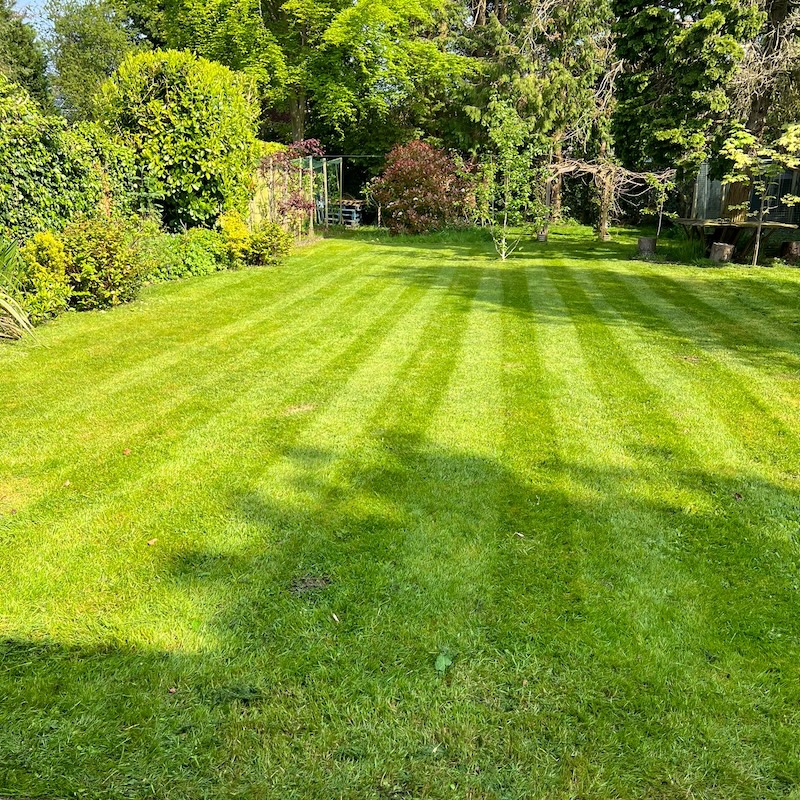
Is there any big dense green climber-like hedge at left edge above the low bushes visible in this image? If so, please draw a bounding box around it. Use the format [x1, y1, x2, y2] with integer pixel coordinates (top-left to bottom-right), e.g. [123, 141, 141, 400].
[0, 74, 140, 239]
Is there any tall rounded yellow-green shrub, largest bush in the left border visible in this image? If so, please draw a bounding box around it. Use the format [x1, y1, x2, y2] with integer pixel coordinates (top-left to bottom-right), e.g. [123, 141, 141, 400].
[99, 50, 258, 230]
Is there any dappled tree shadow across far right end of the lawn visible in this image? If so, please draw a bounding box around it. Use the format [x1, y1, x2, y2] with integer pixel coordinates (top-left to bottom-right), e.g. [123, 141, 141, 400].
[360, 231, 800, 382]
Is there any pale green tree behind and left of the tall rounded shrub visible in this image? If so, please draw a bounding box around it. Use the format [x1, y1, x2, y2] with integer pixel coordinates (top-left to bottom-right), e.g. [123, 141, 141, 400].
[47, 0, 141, 120]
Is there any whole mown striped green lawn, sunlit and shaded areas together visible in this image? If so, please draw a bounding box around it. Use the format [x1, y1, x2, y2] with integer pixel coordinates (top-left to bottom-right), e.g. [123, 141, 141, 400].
[0, 229, 800, 800]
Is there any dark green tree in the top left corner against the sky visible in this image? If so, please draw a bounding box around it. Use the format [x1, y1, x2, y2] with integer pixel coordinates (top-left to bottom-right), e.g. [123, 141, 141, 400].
[0, 0, 51, 109]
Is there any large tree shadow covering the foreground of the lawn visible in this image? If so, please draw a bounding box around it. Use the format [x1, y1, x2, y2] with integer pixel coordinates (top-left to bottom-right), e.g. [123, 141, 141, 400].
[0, 429, 800, 798]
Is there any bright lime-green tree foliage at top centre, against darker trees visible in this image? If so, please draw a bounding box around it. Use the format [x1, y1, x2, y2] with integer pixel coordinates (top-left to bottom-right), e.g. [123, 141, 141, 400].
[152, 0, 459, 141]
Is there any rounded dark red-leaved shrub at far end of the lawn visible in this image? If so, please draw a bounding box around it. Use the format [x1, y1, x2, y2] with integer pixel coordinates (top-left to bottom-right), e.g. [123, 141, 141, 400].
[370, 141, 474, 233]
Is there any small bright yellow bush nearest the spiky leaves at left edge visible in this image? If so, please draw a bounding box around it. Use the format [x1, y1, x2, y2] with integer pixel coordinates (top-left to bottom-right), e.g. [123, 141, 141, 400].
[17, 231, 72, 323]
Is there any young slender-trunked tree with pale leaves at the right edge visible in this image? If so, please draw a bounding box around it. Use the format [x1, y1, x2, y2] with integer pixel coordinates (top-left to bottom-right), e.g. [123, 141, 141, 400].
[722, 125, 800, 266]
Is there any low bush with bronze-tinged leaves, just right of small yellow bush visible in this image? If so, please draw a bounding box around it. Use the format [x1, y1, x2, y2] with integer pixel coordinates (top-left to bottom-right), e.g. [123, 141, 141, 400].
[63, 217, 144, 310]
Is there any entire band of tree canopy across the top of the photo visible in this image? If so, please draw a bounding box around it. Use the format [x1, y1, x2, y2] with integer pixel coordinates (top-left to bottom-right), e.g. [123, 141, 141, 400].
[0, 0, 800, 220]
